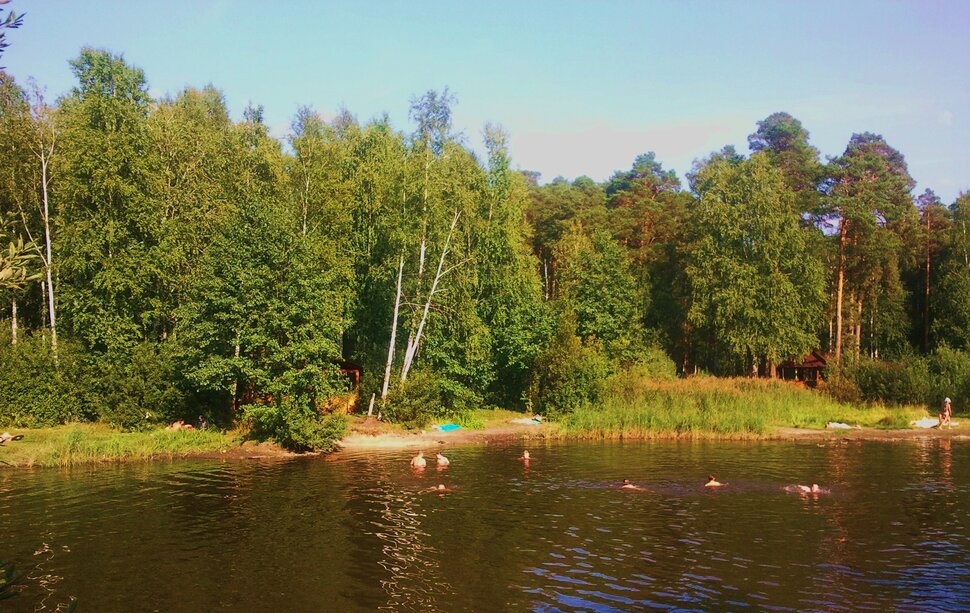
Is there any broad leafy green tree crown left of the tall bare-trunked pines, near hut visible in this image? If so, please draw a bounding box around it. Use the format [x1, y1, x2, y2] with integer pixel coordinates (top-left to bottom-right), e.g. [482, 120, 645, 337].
[687, 154, 825, 371]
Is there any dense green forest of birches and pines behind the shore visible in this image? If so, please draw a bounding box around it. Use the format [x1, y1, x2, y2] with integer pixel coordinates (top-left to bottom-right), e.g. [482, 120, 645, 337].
[0, 49, 970, 447]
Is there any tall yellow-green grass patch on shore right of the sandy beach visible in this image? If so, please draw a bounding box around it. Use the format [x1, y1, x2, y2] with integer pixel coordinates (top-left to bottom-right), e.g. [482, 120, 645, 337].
[560, 377, 927, 438]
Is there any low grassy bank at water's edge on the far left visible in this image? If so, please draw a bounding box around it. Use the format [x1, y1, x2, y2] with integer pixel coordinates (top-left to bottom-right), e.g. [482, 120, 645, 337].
[0, 424, 241, 466]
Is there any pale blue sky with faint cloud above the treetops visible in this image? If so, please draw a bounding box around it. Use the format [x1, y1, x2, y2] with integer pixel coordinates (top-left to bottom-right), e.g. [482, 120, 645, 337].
[2, 0, 970, 203]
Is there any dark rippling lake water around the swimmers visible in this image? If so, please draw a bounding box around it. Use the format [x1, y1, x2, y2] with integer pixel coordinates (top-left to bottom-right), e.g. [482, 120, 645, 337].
[0, 440, 970, 612]
